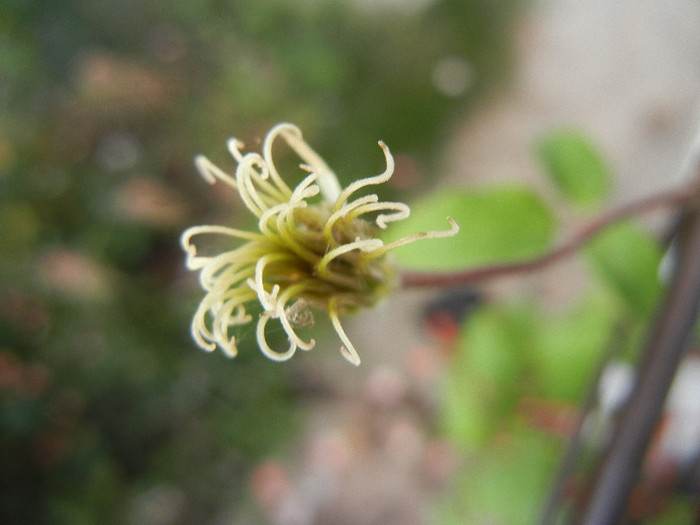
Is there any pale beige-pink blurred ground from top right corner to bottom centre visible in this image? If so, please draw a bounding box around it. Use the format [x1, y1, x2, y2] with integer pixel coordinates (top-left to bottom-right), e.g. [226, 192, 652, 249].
[245, 0, 700, 525]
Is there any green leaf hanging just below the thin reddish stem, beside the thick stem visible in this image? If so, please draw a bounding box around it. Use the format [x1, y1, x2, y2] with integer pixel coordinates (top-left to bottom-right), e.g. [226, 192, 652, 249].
[586, 223, 662, 317]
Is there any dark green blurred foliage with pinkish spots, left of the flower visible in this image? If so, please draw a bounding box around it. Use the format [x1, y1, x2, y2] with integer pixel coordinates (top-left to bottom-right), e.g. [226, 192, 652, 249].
[0, 0, 517, 524]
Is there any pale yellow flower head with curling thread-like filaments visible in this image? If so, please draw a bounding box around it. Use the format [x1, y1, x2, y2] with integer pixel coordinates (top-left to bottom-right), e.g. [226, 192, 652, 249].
[181, 123, 459, 365]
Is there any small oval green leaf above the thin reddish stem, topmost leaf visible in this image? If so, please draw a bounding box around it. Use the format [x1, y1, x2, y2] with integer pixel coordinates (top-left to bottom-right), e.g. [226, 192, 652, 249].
[535, 129, 611, 208]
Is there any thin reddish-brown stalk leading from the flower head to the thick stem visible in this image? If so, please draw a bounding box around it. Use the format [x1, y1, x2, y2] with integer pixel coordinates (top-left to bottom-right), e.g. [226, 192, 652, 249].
[401, 185, 698, 288]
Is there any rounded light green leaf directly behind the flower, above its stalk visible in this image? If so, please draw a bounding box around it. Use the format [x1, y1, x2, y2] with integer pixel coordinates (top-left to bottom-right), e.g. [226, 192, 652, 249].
[387, 186, 554, 271]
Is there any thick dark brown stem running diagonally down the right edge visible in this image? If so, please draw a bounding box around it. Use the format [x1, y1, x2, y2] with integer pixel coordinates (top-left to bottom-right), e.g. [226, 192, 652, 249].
[577, 178, 700, 525]
